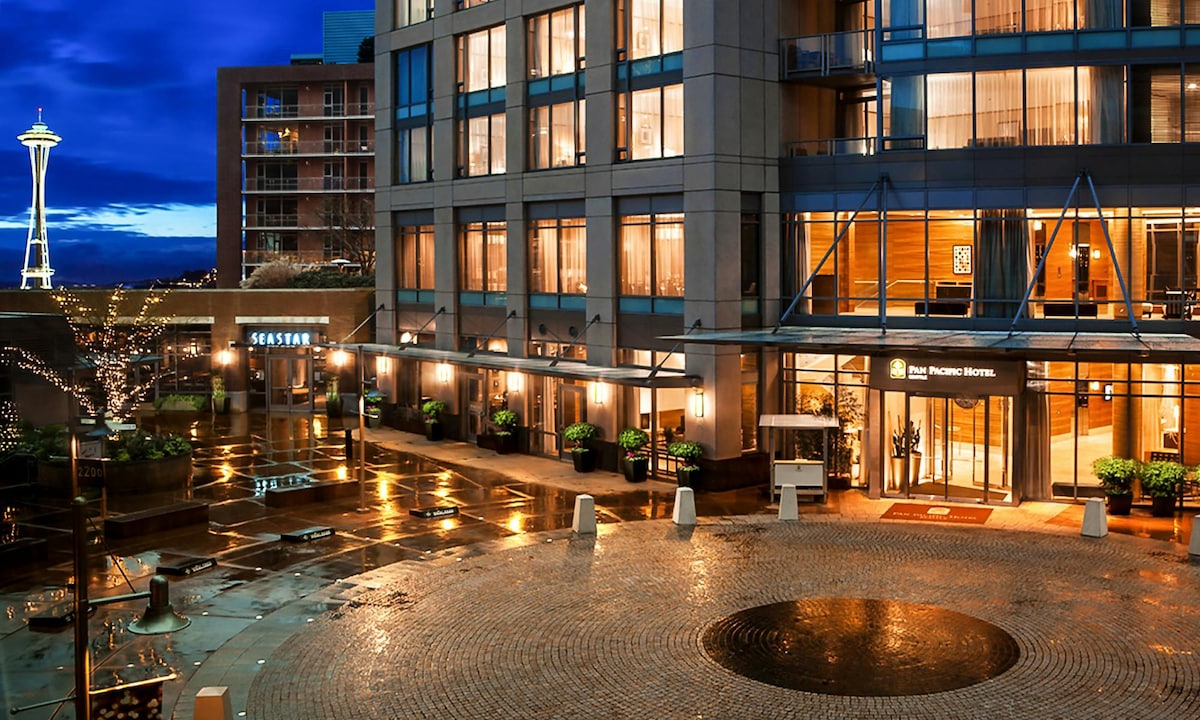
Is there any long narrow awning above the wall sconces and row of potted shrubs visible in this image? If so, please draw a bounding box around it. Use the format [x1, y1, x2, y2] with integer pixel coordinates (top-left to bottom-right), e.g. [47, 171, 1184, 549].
[328, 343, 701, 388]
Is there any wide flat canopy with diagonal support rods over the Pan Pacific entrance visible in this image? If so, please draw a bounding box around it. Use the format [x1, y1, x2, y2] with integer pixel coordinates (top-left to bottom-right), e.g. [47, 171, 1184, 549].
[665, 326, 1200, 362]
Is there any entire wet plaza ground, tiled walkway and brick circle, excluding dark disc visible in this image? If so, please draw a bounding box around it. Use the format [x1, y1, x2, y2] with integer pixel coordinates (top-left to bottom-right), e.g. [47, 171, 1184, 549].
[0, 415, 1200, 720]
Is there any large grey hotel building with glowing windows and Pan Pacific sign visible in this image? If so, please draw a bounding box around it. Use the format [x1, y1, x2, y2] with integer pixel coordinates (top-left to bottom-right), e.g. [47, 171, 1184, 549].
[371, 0, 1200, 504]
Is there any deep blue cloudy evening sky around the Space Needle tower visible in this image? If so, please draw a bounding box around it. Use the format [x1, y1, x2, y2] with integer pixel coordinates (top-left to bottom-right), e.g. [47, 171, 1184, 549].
[0, 0, 373, 287]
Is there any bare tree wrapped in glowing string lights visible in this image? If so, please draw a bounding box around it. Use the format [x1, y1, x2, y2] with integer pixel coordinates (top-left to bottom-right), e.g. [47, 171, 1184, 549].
[0, 288, 169, 422]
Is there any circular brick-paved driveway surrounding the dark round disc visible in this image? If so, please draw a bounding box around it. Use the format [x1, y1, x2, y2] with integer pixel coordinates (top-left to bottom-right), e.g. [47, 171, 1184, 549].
[246, 515, 1200, 720]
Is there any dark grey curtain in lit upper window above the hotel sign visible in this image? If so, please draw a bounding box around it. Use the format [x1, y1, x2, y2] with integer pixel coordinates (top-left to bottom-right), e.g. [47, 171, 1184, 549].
[974, 209, 1033, 318]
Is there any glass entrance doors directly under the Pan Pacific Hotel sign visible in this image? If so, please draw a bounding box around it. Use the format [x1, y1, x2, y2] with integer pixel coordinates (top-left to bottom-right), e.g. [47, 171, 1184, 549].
[884, 392, 1013, 504]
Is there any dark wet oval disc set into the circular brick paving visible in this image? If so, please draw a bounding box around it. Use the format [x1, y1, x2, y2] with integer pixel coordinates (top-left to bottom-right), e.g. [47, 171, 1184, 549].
[704, 598, 1020, 696]
